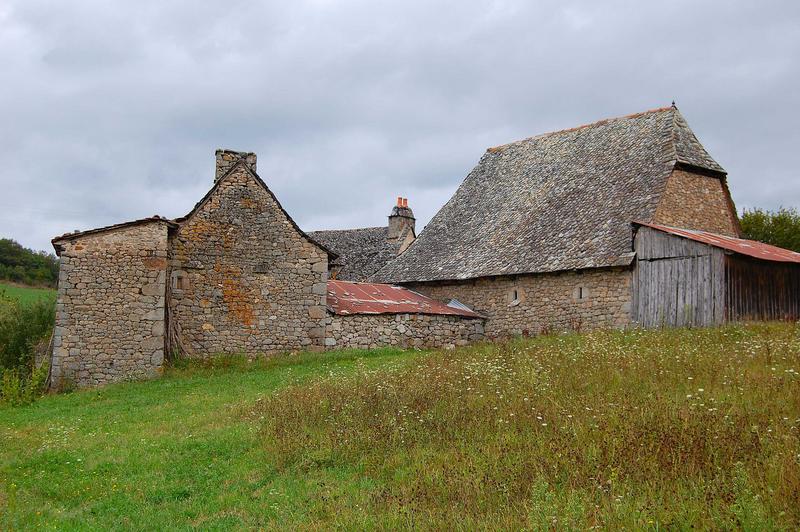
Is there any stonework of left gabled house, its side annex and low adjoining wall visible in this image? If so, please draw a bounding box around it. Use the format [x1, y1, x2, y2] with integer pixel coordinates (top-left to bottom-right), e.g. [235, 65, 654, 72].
[52, 150, 482, 387]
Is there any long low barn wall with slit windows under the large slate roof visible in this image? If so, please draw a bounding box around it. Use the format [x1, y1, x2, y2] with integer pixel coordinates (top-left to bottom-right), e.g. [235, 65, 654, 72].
[408, 269, 631, 338]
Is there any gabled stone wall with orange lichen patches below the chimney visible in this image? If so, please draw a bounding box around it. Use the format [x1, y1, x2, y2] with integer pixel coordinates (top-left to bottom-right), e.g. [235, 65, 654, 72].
[169, 165, 328, 356]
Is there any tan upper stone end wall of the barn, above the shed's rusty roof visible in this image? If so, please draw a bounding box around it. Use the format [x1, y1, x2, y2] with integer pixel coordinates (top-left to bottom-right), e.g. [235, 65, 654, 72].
[652, 170, 739, 237]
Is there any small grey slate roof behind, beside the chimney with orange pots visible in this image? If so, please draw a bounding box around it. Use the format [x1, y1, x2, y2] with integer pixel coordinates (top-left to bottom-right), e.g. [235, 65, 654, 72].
[308, 227, 397, 281]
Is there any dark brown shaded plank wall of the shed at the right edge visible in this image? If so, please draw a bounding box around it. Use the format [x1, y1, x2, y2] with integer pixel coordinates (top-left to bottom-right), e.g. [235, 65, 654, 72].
[725, 255, 800, 321]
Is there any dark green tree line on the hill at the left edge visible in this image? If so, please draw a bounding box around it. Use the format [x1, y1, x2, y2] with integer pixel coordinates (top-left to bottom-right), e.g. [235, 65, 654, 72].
[0, 238, 58, 287]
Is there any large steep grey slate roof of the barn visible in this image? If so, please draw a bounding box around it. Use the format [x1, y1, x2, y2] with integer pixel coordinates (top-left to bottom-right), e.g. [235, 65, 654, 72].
[371, 107, 725, 283]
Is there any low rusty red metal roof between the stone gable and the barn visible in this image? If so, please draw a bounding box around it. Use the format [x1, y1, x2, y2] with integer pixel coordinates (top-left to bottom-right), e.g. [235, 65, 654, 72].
[328, 280, 483, 318]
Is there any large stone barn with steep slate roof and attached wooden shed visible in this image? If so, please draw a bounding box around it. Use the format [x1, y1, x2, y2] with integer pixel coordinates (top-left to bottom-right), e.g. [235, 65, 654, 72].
[372, 105, 800, 337]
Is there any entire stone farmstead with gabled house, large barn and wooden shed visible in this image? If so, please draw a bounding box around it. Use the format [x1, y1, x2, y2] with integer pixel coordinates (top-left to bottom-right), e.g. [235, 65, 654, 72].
[51, 106, 800, 386]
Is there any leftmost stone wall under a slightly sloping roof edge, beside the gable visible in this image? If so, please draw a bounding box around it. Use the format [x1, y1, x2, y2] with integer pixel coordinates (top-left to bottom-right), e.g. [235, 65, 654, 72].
[52, 221, 168, 387]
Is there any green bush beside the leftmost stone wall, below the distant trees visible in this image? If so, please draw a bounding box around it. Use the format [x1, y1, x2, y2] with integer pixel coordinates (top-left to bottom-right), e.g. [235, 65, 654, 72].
[0, 295, 55, 404]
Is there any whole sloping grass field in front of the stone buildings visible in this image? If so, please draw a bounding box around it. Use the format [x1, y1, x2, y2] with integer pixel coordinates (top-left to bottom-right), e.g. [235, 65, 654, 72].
[0, 324, 800, 530]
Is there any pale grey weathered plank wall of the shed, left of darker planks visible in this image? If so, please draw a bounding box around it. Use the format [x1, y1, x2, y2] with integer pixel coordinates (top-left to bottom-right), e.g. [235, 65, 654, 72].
[632, 227, 725, 327]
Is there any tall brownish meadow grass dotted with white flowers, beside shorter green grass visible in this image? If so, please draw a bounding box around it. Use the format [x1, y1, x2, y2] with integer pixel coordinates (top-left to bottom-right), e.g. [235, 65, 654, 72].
[254, 324, 800, 529]
